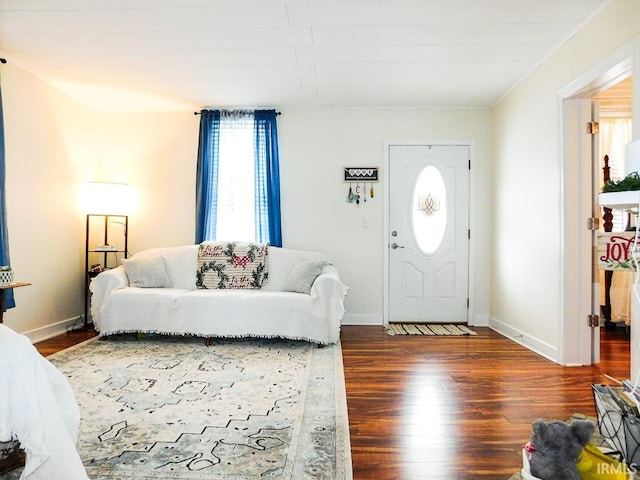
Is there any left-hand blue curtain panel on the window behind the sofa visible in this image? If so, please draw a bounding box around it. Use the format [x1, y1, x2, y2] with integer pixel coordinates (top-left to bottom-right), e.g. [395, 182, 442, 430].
[196, 110, 220, 243]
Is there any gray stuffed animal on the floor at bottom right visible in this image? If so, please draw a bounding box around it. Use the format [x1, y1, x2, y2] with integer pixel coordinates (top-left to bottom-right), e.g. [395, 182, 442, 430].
[529, 419, 595, 480]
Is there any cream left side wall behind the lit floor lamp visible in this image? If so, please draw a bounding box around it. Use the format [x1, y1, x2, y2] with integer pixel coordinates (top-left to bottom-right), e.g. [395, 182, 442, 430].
[0, 64, 98, 338]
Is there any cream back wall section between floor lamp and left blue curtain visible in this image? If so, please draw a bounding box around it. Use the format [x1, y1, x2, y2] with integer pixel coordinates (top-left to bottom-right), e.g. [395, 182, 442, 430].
[95, 111, 200, 249]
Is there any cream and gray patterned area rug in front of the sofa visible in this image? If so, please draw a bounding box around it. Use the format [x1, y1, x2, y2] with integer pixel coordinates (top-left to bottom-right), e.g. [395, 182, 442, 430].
[8, 336, 352, 480]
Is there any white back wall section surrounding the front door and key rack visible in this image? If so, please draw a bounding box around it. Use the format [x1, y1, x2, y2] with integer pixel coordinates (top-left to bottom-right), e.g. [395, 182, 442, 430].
[278, 109, 492, 324]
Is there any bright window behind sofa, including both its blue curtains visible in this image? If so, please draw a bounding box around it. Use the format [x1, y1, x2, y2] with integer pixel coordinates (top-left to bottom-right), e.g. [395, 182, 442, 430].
[196, 110, 282, 246]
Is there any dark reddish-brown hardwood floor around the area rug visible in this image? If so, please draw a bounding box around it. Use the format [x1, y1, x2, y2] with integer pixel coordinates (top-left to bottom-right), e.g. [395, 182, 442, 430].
[31, 326, 630, 480]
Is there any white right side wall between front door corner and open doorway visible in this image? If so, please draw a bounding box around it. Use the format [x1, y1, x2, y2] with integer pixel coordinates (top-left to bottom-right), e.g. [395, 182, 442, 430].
[490, 0, 640, 360]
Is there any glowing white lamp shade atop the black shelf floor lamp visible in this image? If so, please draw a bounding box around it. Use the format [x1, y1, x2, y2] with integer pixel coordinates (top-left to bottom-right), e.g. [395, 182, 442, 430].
[79, 182, 138, 215]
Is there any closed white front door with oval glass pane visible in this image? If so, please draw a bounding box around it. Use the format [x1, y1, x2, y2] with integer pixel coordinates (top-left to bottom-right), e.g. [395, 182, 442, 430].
[388, 145, 470, 323]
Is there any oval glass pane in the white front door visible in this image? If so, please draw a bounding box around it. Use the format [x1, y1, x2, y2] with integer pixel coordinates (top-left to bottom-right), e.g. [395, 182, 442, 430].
[411, 165, 447, 254]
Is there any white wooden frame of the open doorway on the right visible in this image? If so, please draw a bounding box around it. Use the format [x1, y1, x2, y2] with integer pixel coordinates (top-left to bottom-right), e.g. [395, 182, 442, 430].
[557, 39, 640, 370]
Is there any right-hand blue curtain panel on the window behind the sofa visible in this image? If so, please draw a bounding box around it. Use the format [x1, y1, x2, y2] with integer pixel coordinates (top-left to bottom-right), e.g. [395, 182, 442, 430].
[254, 110, 282, 247]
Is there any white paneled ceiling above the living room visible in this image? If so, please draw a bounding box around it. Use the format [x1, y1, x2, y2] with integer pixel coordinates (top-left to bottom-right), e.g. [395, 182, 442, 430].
[0, 0, 610, 111]
